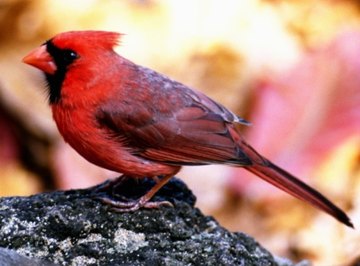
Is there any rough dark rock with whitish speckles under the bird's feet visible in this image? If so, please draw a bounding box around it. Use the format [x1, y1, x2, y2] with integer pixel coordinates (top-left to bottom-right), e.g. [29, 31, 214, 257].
[0, 176, 306, 266]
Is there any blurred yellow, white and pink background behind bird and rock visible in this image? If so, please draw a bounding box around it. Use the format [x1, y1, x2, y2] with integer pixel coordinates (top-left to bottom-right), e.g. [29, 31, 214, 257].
[0, 0, 360, 265]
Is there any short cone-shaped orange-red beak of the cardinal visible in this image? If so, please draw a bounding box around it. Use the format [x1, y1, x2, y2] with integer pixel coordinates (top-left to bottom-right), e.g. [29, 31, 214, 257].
[22, 45, 57, 74]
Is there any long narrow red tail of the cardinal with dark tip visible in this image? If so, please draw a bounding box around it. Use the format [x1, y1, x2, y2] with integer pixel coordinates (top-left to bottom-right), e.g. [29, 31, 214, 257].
[241, 142, 354, 228]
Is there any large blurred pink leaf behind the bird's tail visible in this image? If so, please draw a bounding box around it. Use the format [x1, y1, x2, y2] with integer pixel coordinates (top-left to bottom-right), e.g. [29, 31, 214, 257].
[231, 31, 360, 197]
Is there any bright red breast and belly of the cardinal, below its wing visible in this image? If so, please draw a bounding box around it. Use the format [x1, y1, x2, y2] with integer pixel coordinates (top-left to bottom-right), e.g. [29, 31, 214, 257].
[53, 107, 179, 177]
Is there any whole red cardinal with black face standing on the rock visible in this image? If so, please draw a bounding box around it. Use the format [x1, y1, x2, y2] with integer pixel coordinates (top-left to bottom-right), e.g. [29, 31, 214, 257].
[23, 31, 353, 227]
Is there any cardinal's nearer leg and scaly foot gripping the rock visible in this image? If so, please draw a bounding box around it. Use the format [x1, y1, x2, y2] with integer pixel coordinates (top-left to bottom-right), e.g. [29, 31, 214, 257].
[96, 175, 173, 212]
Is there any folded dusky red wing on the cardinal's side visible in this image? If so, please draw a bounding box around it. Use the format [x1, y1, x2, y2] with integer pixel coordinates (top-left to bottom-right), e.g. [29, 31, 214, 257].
[97, 65, 251, 165]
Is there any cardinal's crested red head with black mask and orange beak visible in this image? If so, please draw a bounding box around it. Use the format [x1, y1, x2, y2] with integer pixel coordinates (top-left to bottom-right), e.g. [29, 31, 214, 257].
[23, 31, 121, 104]
